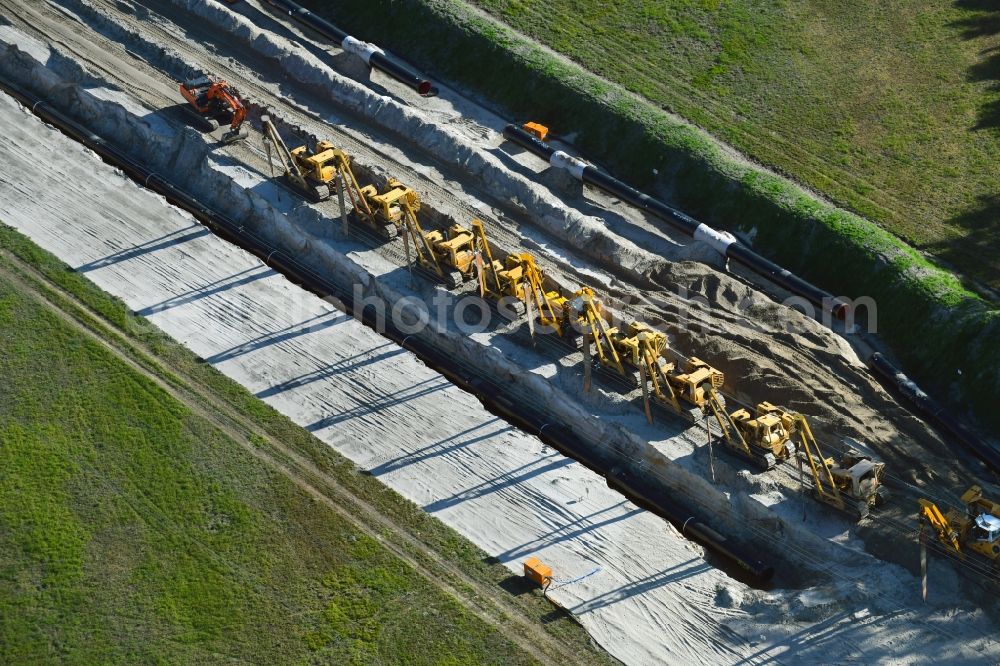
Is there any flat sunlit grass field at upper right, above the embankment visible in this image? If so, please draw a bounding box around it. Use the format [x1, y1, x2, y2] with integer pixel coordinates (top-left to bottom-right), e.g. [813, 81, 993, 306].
[473, 0, 1000, 288]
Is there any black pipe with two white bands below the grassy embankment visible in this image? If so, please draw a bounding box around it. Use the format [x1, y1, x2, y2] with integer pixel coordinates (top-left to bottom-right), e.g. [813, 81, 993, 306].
[503, 125, 849, 319]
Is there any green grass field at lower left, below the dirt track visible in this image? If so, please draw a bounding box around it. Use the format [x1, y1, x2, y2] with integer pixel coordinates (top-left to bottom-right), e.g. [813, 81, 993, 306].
[0, 231, 564, 664]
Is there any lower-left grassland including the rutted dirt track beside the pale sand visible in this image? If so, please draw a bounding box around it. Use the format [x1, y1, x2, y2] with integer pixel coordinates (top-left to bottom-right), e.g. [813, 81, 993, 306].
[0, 224, 617, 664]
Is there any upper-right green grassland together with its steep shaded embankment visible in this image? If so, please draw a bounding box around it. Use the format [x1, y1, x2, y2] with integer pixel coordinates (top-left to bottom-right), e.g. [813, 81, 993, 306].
[304, 0, 1000, 428]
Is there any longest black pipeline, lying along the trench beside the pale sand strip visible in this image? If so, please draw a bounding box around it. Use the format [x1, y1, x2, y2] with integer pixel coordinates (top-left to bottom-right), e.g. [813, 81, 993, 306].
[0, 72, 774, 583]
